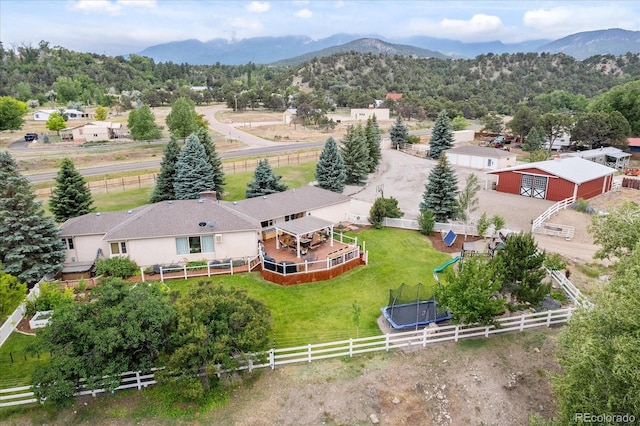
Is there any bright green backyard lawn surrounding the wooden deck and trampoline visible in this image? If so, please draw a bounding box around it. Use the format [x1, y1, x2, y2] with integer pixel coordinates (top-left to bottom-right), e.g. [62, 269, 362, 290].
[166, 229, 450, 347]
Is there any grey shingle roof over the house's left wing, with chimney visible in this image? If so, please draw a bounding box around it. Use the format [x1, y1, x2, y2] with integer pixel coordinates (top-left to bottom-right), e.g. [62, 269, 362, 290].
[61, 198, 259, 241]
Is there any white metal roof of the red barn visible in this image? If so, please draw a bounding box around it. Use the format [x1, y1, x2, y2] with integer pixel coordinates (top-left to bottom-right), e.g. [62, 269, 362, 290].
[487, 157, 616, 185]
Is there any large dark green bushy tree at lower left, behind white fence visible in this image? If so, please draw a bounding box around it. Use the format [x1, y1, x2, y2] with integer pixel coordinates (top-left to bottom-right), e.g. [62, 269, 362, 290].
[32, 278, 176, 404]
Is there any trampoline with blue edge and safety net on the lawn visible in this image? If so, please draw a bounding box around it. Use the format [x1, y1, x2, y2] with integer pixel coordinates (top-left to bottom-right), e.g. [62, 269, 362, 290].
[381, 283, 451, 330]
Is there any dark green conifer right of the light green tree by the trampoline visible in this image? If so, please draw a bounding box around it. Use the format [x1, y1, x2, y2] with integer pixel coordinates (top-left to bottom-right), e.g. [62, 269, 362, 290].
[497, 233, 551, 307]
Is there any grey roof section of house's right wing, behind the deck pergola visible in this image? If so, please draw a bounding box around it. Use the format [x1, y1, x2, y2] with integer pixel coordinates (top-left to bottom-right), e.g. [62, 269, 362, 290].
[227, 185, 350, 222]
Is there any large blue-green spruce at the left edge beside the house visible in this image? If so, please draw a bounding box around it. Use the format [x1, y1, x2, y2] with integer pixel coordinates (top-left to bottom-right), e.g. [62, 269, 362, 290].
[0, 152, 65, 286]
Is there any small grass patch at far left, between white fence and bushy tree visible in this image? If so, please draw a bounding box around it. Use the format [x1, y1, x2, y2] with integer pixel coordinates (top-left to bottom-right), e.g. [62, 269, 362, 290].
[0, 332, 49, 389]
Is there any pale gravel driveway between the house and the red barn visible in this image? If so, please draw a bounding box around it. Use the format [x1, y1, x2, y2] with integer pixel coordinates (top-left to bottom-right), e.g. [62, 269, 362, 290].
[349, 149, 554, 231]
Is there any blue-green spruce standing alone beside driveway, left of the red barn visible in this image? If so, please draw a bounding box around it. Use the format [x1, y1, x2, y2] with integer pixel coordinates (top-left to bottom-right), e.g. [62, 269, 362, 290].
[420, 155, 458, 222]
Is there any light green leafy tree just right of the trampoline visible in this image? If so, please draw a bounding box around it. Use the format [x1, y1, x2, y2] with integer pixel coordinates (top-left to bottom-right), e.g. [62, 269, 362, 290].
[436, 256, 505, 325]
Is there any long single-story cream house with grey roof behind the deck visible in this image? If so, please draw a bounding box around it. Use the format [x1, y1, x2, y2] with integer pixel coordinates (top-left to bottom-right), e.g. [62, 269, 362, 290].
[60, 186, 350, 272]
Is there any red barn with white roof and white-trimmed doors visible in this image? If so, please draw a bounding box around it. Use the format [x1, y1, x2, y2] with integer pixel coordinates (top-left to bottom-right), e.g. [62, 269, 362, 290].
[488, 157, 616, 201]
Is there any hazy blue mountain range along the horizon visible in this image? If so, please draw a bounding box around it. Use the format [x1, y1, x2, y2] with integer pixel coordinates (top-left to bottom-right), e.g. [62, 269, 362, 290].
[138, 28, 640, 65]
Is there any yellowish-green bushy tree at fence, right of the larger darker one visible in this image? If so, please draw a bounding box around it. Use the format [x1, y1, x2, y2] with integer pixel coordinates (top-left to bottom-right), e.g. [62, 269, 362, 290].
[168, 281, 271, 399]
